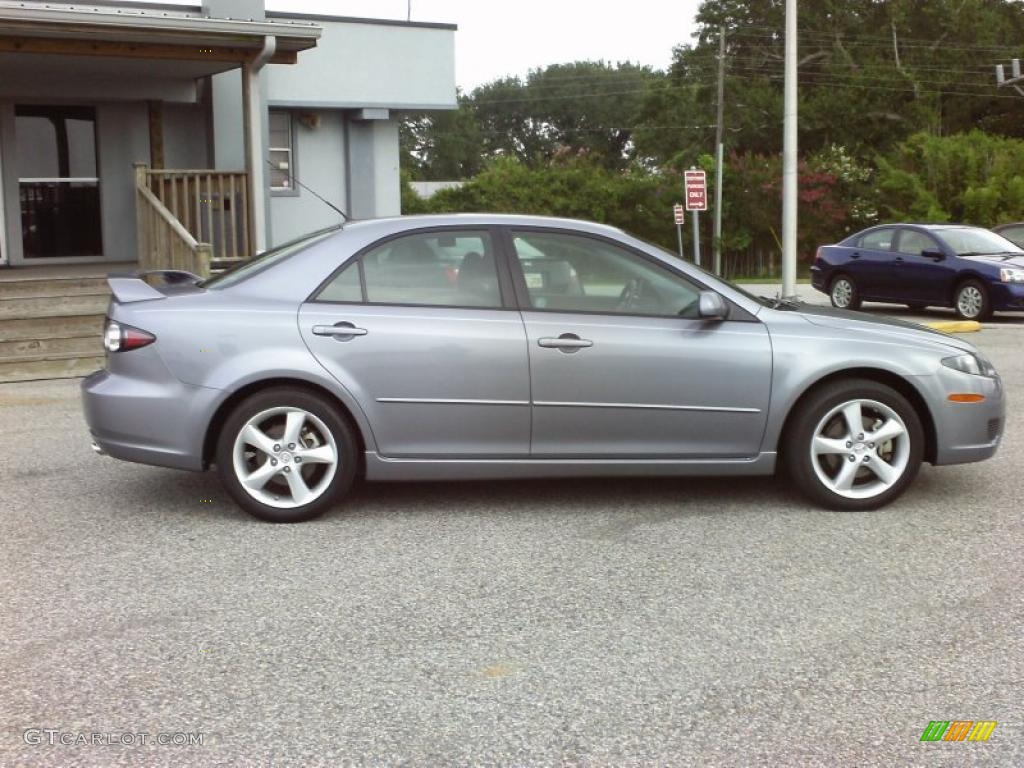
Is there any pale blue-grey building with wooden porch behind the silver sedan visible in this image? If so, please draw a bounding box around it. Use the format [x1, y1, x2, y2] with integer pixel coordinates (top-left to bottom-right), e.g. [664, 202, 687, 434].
[0, 0, 456, 274]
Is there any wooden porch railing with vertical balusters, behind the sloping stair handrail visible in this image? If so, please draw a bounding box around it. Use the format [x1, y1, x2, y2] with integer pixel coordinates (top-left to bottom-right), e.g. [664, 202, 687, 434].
[135, 164, 253, 268]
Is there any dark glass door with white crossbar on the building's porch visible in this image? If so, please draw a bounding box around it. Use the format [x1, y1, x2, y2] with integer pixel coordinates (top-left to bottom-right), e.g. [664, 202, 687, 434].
[14, 104, 103, 260]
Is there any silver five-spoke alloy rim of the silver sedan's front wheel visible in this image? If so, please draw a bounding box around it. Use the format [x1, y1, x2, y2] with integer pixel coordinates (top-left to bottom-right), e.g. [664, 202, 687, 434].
[810, 399, 910, 499]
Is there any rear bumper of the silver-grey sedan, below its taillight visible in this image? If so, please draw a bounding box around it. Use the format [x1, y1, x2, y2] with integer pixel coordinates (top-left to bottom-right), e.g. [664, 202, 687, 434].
[82, 350, 221, 470]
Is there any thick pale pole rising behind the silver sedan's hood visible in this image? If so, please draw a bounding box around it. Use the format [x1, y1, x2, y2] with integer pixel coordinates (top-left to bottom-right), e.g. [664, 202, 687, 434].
[782, 0, 798, 298]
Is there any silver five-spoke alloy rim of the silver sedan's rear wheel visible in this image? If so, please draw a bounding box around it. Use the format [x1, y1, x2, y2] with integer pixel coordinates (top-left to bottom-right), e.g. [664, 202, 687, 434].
[232, 407, 340, 509]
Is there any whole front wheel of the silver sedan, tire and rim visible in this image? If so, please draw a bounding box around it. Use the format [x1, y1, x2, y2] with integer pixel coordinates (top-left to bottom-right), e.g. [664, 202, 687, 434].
[783, 380, 925, 511]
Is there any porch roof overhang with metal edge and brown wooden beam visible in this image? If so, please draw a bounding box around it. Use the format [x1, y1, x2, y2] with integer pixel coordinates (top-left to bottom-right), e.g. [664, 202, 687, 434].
[0, 0, 322, 67]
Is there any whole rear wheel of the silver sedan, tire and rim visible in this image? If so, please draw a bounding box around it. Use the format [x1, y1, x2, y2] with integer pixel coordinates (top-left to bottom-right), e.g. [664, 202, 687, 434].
[216, 387, 356, 522]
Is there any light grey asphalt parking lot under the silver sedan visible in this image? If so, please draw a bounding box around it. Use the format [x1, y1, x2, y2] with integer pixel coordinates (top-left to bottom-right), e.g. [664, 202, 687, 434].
[0, 303, 1024, 766]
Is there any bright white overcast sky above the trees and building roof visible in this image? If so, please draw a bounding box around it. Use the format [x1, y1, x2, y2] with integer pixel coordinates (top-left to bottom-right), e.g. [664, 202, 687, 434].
[117, 0, 700, 91]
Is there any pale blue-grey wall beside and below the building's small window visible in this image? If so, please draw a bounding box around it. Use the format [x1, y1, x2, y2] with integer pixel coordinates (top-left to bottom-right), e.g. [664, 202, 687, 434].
[270, 110, 349, 245]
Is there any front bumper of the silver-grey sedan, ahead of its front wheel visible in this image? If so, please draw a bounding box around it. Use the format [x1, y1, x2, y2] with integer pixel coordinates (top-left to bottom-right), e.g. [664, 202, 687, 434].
[929, 367, 1007, 465]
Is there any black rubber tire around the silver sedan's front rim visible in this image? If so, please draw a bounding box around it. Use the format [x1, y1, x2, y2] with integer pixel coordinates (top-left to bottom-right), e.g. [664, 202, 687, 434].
[781, 379, 925, 512]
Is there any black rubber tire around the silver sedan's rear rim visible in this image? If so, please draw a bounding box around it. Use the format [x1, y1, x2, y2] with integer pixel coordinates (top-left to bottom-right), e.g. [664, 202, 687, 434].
[216, 387, 358, 523]
